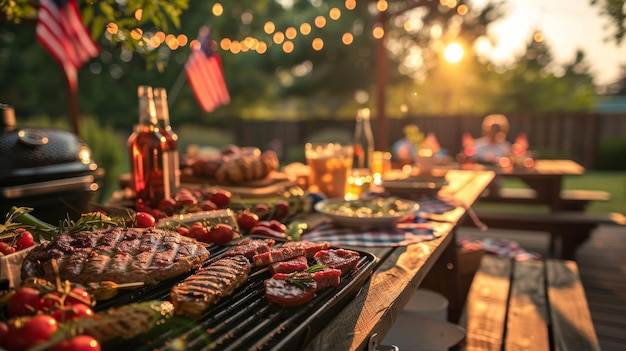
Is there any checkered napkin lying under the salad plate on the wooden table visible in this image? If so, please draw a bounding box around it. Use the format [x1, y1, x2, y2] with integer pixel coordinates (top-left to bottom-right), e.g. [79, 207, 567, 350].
[302, 216, 440, 247]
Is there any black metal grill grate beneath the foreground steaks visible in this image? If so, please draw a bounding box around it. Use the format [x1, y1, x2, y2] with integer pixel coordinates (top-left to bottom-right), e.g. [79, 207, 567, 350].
[96, 239, 376, 351]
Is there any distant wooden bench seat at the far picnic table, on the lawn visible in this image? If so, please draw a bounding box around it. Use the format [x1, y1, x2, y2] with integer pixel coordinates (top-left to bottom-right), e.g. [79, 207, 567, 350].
[481, 188, 611, 211]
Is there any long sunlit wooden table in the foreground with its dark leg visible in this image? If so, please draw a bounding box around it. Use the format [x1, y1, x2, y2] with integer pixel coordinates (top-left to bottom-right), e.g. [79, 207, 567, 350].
[305, 170, 495, 350]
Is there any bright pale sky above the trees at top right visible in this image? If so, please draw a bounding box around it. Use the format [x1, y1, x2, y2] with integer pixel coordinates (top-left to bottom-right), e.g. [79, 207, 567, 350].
[473, 0, 626, 85]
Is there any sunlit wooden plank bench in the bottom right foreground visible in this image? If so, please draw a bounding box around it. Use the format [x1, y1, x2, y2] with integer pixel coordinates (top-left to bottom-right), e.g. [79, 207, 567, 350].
[460, 255, 600, 351]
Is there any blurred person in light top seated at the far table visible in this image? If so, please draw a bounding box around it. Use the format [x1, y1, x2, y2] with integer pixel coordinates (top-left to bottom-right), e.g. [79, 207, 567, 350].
[474, 114, 511, 163]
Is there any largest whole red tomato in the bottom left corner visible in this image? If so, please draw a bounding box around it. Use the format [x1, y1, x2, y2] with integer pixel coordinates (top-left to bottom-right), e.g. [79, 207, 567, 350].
[7, 314, 59, 350]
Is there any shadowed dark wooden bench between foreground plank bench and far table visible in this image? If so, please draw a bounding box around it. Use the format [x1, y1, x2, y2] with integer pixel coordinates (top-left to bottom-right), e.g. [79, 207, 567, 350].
[461, 209, 626, 260]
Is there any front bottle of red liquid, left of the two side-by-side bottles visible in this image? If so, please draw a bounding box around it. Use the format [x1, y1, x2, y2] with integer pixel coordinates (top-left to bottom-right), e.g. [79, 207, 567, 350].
[128, 85, 166, 210]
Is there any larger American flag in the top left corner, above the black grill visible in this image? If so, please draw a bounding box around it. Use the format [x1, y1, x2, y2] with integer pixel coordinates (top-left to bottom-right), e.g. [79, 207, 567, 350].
[37, 0, 100, 91]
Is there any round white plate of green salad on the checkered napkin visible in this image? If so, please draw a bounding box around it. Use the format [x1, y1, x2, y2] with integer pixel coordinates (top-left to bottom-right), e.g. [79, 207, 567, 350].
[315, 197, 419, 229]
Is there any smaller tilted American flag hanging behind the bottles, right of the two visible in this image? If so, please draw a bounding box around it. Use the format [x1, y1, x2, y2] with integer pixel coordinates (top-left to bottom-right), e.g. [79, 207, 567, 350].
[185, 26, 230, 112]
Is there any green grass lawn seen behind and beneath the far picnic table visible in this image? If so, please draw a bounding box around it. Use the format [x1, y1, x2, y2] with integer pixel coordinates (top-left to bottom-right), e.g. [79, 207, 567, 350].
[477, 171, 626, 214]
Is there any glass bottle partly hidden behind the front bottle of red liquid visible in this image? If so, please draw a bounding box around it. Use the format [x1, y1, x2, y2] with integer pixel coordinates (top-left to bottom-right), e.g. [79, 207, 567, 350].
[153, 88, 180, 198]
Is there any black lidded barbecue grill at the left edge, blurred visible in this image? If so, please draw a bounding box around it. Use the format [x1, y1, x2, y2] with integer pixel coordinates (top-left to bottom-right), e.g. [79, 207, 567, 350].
[0, 104, 103, 223]
